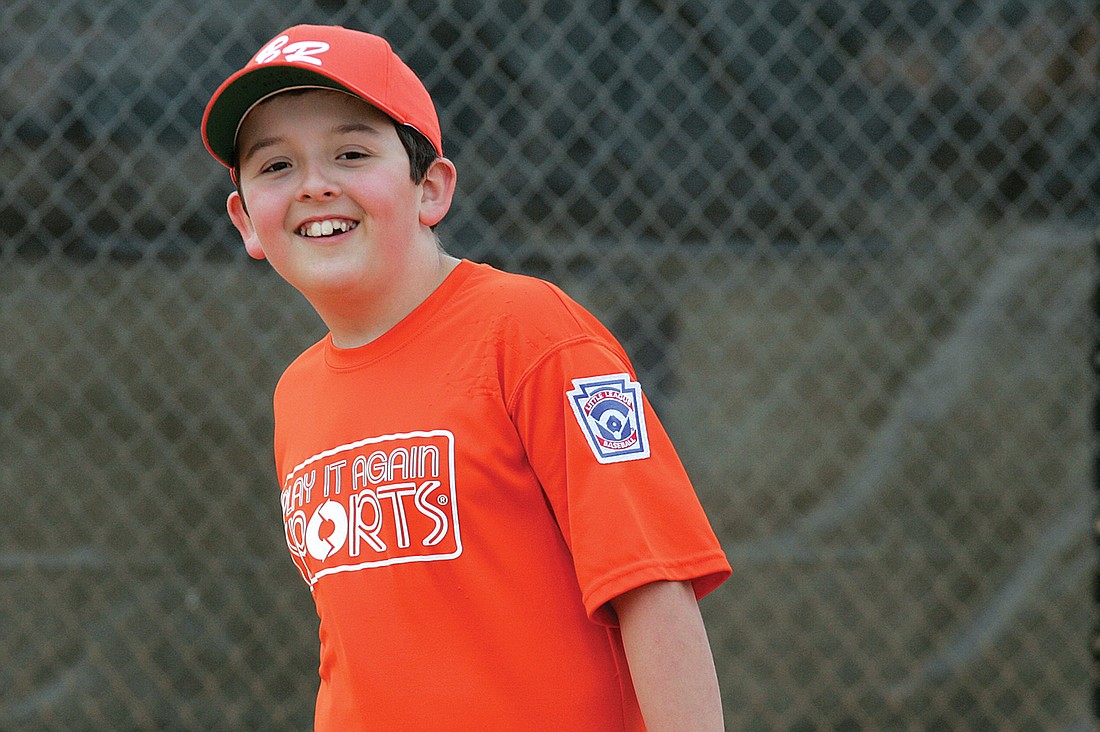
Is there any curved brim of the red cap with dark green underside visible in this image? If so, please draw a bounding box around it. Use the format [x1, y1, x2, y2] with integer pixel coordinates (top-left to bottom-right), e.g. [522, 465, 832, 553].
[202, 66, 349, 167]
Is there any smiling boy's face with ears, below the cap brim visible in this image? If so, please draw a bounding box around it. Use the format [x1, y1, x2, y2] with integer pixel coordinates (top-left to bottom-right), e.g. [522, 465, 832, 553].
[228, 90, 453, 306]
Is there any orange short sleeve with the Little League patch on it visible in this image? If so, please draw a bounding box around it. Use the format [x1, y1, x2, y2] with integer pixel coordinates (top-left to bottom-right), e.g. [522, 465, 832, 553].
[509, 337, 730, 624]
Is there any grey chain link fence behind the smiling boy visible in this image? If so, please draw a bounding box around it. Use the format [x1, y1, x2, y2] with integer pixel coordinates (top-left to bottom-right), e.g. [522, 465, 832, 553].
[0, 0, 1100, 730]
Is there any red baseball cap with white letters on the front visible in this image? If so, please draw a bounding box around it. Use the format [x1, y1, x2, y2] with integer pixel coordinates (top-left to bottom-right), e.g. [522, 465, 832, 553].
[202, 25, 443, 167]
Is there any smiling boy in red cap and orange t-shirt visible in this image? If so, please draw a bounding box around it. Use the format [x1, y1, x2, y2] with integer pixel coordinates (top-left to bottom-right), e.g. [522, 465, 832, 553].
[202, 26, 730, 732]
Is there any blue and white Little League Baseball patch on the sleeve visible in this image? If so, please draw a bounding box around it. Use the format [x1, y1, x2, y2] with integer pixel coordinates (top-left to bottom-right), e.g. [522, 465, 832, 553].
[567, 373, 649, 463]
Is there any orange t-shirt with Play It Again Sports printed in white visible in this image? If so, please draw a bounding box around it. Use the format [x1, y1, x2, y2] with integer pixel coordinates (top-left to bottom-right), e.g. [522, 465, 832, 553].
[275, 261, 729, 732]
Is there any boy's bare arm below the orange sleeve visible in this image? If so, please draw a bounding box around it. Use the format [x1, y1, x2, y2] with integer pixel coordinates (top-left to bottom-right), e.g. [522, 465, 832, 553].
[612, 581, 724, 732]
